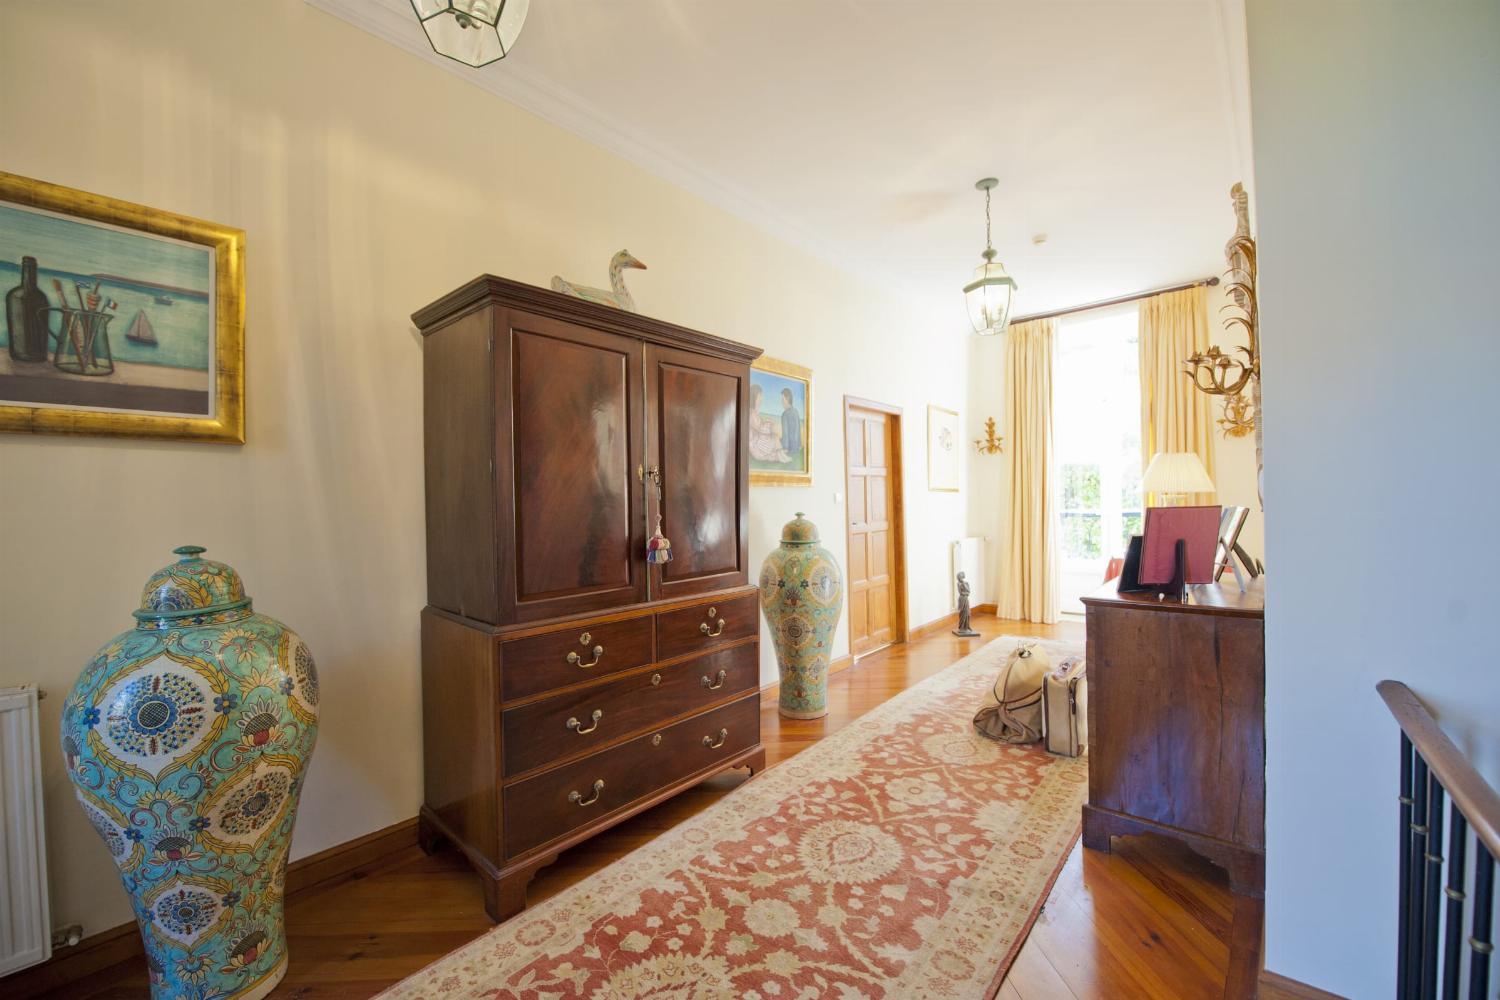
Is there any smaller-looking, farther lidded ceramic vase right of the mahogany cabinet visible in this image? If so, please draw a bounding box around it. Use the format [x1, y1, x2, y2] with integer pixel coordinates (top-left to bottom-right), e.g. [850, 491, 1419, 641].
[761, 511, 843, 718]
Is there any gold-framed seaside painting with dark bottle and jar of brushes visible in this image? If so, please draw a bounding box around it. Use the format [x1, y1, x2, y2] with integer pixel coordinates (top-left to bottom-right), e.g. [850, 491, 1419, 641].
[0, 171, 245, 444]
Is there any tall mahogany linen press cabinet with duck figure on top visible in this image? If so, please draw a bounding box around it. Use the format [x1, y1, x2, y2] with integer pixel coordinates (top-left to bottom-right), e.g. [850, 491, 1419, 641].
[413, 276, 765, 921]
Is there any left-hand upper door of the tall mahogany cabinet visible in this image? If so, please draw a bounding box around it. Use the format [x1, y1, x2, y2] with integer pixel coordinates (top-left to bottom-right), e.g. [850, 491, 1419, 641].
[495, 310, 647, 621]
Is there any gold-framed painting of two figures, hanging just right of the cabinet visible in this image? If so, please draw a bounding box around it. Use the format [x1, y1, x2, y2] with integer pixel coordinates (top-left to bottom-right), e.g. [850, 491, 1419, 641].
[746, 357, 813, 486]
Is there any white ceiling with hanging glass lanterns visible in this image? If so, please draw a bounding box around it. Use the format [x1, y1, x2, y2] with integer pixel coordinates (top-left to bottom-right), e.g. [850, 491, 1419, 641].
[308, 0, 1253, 320]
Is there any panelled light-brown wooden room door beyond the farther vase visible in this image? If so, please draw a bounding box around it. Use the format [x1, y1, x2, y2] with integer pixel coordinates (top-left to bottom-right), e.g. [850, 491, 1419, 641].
[845, 397, 906, 657]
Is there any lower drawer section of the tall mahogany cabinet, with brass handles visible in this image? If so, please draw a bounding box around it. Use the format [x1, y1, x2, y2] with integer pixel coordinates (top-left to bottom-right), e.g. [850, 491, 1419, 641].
[422, 586, 765, 921]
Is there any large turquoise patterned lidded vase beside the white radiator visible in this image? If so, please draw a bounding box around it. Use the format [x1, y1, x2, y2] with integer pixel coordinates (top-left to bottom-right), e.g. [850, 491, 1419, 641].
[62, 546, 318, 1000]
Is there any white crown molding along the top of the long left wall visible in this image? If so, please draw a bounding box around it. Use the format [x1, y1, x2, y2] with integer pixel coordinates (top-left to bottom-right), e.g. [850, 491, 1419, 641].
[305, 0, 866, 280]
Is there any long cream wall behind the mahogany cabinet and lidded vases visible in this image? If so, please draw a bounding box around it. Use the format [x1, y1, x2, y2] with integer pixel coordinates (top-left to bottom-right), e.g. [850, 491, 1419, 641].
[0, 0, 966, 933]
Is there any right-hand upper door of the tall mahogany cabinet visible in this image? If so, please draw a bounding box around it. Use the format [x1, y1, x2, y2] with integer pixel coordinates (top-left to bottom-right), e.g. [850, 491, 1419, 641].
[645, 345, 750, 600]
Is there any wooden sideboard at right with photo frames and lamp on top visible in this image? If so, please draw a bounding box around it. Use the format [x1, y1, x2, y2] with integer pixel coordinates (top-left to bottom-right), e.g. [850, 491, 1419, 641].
[1083, 577, 1266, 897]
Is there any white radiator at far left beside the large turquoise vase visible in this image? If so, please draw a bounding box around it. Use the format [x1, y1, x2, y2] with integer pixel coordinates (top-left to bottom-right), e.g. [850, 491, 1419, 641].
[0, 685, 53, 976]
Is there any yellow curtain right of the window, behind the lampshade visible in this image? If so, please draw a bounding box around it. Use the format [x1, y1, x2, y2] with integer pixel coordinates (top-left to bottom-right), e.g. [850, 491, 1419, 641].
[1140, 285, 1218, 504]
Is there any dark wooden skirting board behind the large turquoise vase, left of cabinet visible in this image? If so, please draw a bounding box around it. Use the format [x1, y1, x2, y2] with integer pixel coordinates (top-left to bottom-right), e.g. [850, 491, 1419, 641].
[0, 817, 422, 1000]
